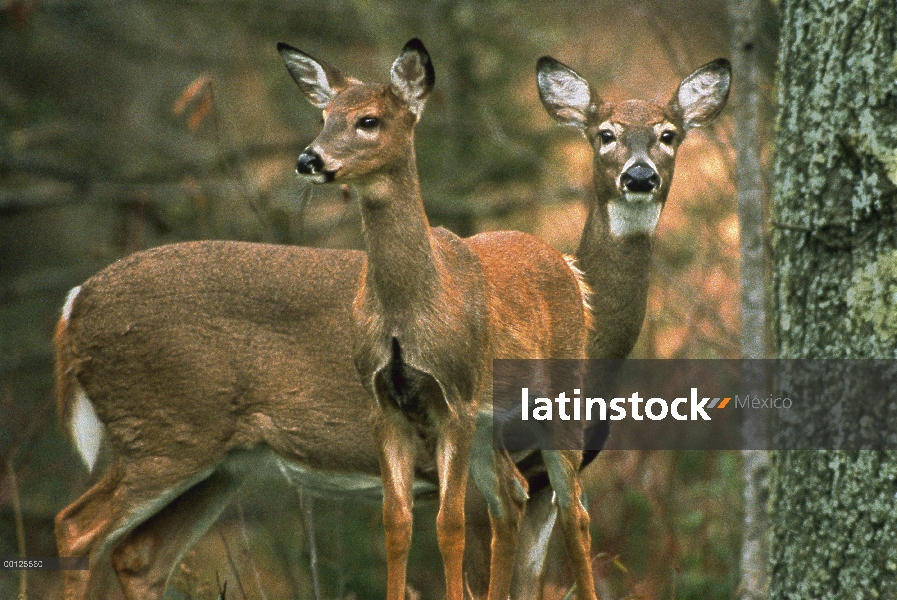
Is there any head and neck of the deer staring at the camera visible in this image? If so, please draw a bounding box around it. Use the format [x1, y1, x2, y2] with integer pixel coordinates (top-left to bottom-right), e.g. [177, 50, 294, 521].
[528, 56, 731, 583]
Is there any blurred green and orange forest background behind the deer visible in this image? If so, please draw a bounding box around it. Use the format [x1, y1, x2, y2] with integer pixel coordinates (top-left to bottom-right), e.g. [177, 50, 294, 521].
[0, 0, 776, 600]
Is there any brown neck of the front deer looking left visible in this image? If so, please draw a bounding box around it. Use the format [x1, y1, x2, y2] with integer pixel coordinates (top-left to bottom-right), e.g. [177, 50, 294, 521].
[356, 155, 438, 317]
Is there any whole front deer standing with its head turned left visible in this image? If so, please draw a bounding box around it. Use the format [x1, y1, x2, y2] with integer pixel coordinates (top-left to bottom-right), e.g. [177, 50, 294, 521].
[281, 40, 595, 600]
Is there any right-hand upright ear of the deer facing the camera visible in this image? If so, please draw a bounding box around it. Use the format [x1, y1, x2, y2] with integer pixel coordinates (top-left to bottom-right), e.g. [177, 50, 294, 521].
[670, 58, 732, 129]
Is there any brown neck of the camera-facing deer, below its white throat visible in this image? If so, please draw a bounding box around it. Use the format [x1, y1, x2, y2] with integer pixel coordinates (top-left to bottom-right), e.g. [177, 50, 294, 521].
[576, 198, 653, 358]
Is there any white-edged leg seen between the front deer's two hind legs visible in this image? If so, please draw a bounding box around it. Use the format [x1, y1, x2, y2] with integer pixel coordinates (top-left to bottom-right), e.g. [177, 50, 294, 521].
[511, 486, 557, 600]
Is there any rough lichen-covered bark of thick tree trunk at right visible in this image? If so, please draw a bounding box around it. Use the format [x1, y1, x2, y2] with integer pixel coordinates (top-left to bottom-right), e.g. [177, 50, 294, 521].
[770, 0, 897, 599]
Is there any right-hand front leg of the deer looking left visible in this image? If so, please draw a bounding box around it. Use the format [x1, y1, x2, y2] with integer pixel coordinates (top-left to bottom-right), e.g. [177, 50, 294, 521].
[436, 418, 474, 600]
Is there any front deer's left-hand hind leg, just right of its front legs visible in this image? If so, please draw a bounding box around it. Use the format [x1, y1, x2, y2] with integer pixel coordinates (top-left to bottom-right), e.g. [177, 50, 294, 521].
[470, 413, 527, 600]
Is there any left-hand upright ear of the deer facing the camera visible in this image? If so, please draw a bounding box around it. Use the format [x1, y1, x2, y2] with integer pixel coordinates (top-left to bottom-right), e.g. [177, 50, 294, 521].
[536, 56, 599, 129]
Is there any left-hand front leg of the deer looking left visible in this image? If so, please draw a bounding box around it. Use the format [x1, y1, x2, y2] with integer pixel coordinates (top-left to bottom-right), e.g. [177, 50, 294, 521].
[374, 408, 414, 600]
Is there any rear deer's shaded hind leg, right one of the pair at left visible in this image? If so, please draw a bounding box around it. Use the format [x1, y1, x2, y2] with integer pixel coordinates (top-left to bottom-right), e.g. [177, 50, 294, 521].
[112, 470, 241, 600]
